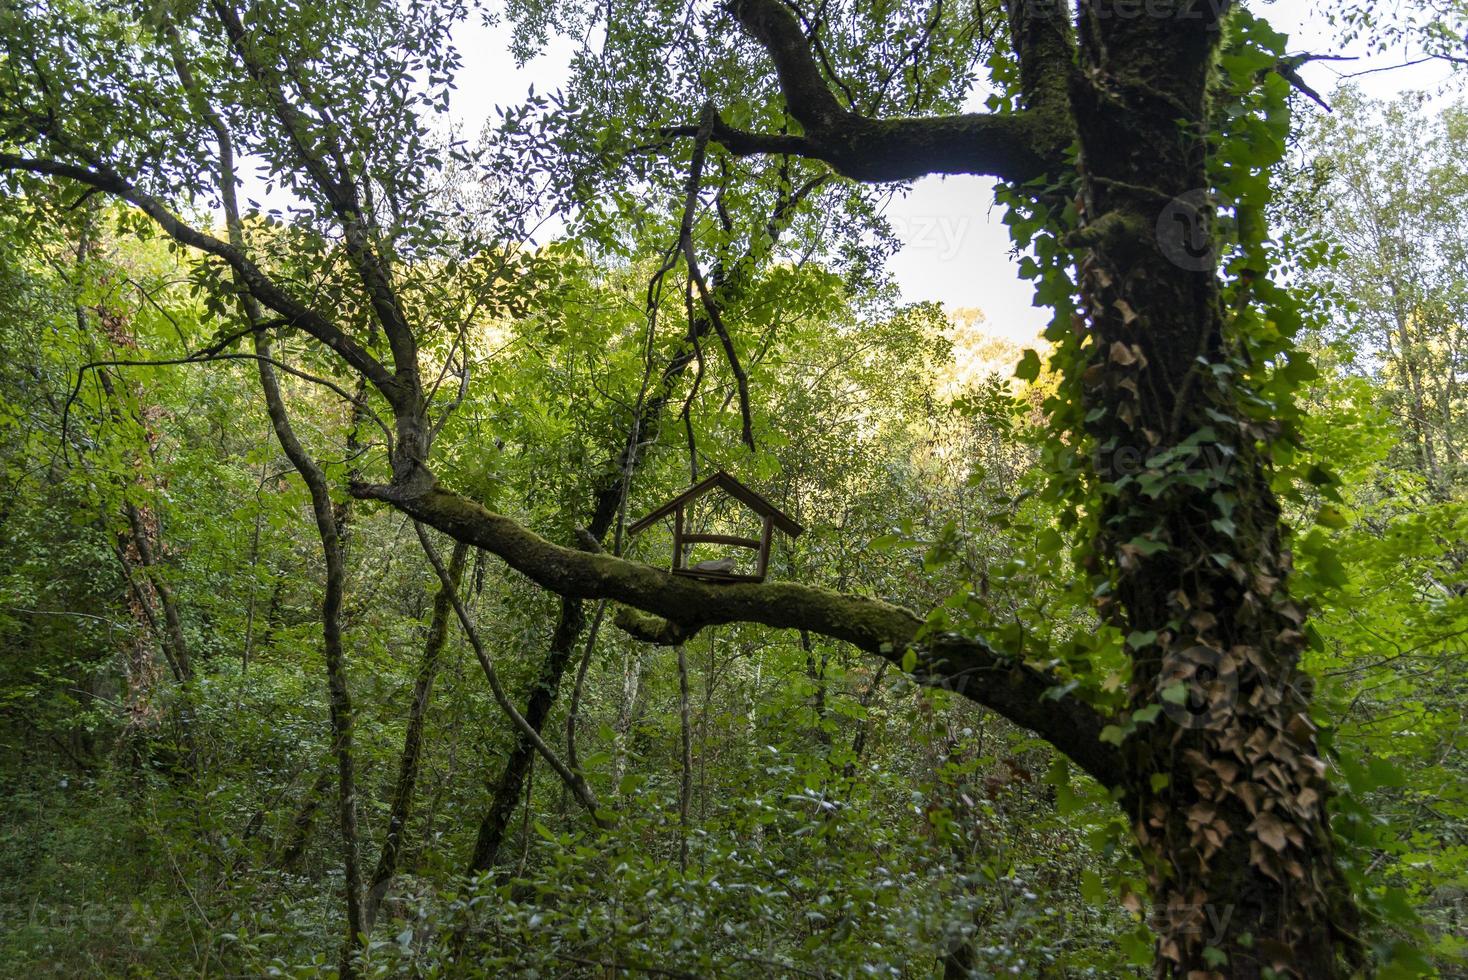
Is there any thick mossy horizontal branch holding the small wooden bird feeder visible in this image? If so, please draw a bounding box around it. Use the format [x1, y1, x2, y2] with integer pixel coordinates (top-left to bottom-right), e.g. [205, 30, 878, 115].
[352, 483, 1122, 786]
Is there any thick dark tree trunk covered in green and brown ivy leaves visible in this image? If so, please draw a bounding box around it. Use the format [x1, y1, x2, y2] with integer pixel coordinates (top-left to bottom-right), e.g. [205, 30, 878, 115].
[1072, 3, 1355, 980]
